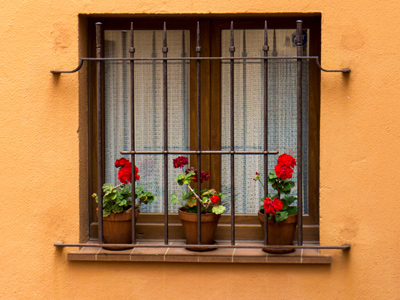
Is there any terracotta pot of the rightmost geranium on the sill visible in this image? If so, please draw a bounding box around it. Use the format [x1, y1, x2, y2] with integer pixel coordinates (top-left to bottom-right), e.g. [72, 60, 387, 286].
[258, 211, 297, 254]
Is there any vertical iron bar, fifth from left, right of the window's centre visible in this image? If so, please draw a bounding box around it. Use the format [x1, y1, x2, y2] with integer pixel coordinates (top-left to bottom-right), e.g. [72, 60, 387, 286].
[229, 21, 235, 245]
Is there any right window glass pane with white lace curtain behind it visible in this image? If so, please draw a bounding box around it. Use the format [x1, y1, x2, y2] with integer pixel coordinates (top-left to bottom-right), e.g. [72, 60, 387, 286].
[221, 29, 309, 214]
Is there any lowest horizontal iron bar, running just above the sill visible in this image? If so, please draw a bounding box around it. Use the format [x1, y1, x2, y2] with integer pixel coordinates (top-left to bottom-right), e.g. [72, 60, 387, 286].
[54, 242, 351, 250]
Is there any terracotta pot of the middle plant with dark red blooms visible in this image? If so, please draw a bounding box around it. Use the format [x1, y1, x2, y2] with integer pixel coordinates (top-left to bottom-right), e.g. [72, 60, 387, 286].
[179, 207, 221, 251]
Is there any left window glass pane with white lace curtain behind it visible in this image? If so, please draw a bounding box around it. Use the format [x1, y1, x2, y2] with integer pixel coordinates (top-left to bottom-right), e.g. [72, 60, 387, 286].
[104, 30, 190, 212]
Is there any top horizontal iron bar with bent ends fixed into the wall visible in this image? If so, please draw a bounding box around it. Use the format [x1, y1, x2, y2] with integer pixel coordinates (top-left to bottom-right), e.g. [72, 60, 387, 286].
[50, 56, 351, 74]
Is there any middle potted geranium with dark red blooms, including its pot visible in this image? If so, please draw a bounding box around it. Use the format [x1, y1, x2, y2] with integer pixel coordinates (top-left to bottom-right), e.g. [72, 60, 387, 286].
[171, 156, 226, 251]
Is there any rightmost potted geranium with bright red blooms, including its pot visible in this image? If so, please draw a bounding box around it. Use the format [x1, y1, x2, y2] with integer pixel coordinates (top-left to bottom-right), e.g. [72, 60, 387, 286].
[253, 154, 297, 253]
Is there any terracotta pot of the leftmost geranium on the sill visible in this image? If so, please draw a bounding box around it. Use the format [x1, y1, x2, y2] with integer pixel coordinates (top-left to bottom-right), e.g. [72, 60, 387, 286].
[103, 208, 139, 250]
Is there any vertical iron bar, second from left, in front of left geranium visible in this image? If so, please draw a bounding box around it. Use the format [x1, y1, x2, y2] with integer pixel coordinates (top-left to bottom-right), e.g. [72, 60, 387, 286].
[129, 22, 136, 244]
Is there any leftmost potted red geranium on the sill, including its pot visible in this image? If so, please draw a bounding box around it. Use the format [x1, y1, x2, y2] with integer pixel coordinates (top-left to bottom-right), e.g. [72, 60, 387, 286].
[92, 158, 157, 250]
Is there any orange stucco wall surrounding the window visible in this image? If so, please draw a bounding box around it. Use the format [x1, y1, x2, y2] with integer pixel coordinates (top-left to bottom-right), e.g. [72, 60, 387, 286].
[0, 0, 400, 299]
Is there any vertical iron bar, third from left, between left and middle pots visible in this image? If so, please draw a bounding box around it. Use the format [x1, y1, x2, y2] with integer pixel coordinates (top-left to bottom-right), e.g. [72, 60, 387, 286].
[162, 22, 168, 245]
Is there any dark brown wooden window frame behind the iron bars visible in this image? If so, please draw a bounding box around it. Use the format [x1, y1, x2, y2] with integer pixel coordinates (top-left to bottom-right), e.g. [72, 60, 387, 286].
[88, 14, 321, 241]
